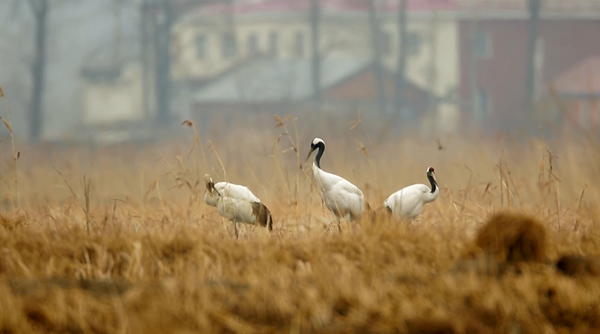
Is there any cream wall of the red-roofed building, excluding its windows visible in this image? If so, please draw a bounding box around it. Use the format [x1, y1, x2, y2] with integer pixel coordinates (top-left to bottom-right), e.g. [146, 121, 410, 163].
[172, 13, 458, 96]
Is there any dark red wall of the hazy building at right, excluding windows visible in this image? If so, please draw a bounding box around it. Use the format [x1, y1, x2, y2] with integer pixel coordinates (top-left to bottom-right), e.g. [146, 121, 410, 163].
[459, 18, 600, 128]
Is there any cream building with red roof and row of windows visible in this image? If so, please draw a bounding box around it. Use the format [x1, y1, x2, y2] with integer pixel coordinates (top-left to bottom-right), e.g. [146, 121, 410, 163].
[172, 0, 459, 104]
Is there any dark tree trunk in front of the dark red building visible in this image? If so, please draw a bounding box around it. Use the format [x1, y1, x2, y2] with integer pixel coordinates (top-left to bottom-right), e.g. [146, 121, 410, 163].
[525, 0, 541, 112]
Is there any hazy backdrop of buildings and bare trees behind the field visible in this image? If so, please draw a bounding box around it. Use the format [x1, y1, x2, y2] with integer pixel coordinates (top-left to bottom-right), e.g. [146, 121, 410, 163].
[0, 0, 600, 143]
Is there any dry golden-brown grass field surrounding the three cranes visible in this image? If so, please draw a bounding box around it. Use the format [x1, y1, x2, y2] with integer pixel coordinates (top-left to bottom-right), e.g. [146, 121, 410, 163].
[0, 113, 600, 334]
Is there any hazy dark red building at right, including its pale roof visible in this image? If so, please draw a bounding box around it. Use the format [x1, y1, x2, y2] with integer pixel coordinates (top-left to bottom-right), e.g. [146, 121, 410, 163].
[458, 0, 600, 130]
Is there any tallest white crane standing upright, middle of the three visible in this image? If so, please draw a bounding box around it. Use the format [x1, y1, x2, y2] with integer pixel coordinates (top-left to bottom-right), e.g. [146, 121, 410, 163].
[306, 138, 370, 233]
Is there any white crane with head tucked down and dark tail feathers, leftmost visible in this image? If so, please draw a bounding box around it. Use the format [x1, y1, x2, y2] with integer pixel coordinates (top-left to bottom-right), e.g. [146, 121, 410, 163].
[204, 174, 273, 238]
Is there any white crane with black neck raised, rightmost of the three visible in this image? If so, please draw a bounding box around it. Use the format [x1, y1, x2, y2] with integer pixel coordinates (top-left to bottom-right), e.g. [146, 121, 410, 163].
[383, 166, 440, 221]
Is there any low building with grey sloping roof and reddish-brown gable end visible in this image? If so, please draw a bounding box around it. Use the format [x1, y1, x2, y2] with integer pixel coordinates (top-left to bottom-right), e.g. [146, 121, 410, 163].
[192, 57, 429, 129]
